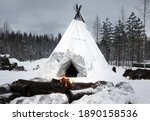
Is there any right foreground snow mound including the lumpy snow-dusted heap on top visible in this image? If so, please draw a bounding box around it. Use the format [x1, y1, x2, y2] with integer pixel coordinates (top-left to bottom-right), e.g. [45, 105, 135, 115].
[73, 82, 139, 104]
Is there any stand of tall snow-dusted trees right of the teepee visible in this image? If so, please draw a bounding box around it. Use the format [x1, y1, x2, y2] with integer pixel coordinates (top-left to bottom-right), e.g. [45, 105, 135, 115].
[94, 12, 150, 66]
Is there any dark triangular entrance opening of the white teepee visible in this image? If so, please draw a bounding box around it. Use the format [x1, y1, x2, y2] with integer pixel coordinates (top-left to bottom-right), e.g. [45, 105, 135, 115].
[65, 63, 78, 77]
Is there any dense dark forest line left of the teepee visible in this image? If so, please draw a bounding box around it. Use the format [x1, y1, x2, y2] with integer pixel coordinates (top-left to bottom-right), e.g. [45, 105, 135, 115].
[0, 22, 61, 61]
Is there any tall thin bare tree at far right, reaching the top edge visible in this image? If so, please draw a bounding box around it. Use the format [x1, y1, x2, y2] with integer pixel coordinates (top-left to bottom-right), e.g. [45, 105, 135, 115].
[136, 0, 150, 68]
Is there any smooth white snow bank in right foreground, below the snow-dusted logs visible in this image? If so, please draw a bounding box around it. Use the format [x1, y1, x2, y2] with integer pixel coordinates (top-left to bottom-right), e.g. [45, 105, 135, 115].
[73, 89, 137, 104]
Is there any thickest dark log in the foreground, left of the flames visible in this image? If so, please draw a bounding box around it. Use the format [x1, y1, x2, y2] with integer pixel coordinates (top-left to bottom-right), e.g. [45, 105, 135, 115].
[10, 79, 67, 97]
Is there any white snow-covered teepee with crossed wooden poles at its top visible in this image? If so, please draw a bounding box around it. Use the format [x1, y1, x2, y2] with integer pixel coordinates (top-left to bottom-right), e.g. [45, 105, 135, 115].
[38, 5, 114, 81]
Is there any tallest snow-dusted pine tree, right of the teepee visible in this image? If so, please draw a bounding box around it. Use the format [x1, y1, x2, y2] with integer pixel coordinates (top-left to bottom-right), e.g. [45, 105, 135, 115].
[126, 12, 144, 64]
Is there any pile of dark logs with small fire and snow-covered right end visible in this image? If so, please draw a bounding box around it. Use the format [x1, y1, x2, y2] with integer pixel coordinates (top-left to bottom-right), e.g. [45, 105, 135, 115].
[0, 79, 134, 103]
